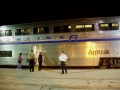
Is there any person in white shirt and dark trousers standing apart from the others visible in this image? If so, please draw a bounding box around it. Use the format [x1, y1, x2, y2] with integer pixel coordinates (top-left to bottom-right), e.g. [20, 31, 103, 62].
[59, 51, 68, 74]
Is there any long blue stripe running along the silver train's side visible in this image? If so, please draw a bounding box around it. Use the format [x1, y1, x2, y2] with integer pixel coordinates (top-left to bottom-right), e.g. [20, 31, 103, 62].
[0, 38, 120, 45]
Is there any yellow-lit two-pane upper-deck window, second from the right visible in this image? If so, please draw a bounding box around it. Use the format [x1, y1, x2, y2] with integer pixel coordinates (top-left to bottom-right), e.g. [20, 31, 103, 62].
[75, 24, 94, 32]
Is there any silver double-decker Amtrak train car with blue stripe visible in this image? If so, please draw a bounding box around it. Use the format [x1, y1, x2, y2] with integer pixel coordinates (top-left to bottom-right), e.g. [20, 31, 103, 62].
[0, 16, 120, 68]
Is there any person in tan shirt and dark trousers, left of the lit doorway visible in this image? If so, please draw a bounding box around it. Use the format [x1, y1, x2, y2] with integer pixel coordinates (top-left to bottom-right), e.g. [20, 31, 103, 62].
[28, 50, 35, 72]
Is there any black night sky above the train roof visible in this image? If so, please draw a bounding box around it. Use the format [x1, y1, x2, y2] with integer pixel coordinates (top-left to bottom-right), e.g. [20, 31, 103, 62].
[0, 1, 120, 25]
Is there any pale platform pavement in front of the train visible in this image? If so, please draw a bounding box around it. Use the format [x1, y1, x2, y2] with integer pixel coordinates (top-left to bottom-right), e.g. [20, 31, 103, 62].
[0, 68, 120, 90]
